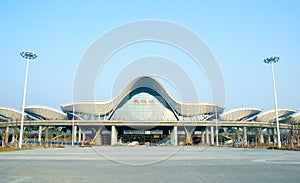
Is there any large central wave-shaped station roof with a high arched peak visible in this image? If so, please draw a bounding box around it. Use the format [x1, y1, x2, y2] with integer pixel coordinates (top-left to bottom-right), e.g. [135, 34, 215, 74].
[61, 75, 225, 116]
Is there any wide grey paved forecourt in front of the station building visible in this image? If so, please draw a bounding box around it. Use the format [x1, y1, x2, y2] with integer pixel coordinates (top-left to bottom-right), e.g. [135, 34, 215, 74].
[0, 147, 300, 182]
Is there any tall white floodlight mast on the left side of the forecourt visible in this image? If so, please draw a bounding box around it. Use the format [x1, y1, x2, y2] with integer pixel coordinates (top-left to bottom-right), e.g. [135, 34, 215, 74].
[19, 52, 37, 148]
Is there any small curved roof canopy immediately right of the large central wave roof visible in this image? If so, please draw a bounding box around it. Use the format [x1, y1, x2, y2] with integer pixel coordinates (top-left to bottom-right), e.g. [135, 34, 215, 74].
[221, 107, 262, 121]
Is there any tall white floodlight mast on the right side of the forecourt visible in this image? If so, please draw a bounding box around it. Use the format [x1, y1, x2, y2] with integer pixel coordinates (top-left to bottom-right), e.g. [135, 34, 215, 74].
[264, 57, 281, 149]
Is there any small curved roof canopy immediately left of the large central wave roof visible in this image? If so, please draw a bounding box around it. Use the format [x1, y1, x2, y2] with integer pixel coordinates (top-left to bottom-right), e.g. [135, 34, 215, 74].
[24, 106, 67, 120]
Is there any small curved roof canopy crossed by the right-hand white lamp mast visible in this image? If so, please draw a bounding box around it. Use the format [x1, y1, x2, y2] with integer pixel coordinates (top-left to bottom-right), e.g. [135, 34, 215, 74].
[256, 109, 297, 122]
